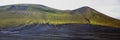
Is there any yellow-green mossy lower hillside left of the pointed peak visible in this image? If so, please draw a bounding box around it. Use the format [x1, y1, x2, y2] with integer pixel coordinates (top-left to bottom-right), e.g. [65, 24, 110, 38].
[0, 12, 86, 27]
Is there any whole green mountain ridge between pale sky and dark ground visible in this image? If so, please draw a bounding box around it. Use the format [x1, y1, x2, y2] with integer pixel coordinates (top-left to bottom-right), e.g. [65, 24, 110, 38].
[0, 4, 120, 28]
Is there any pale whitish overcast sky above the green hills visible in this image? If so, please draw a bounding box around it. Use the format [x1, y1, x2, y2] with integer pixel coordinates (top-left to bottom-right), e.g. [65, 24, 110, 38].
[0, 0, 120, 19]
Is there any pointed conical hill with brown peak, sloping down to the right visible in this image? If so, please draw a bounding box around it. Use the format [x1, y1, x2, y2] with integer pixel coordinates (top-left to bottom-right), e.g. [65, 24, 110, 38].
[72, 6, 120, 27]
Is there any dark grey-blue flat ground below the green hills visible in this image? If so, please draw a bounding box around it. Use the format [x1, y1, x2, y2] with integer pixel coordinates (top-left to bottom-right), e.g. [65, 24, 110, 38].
[0, 24, 120, 40]
